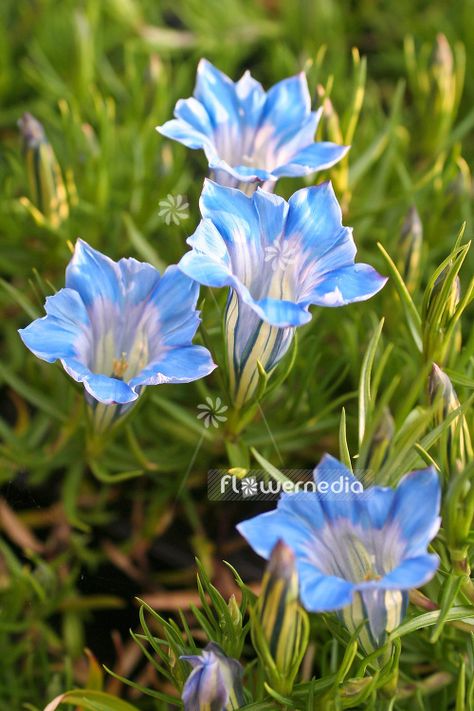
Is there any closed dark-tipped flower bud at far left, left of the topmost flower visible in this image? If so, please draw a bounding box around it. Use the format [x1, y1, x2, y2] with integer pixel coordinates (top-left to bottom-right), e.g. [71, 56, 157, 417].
[18, 113, 69, 228]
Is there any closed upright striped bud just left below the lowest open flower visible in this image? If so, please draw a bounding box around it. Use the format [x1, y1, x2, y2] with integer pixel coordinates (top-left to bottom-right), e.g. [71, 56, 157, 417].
[252, 541, 308, 695]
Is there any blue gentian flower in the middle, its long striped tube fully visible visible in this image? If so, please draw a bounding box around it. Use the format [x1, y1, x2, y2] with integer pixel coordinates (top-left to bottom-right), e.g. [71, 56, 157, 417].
[178, 180, 386, 406]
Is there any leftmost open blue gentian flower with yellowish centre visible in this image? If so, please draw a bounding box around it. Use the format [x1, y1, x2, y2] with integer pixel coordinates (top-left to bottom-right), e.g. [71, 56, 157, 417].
[19, 240, 216, 428]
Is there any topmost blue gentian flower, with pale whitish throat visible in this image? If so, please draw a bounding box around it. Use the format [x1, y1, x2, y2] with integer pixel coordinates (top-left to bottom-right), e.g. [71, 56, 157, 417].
[157, 59, 348, 188]
